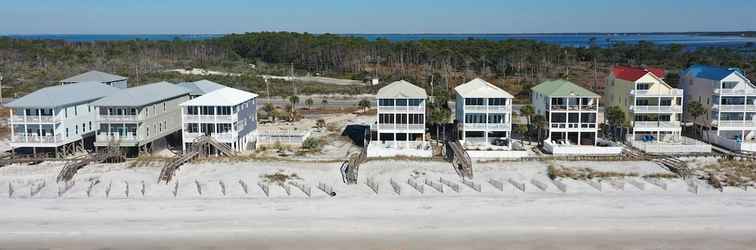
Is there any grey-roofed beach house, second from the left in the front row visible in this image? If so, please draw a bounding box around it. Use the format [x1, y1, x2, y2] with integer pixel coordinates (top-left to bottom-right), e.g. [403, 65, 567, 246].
[93, 82, 189, 157]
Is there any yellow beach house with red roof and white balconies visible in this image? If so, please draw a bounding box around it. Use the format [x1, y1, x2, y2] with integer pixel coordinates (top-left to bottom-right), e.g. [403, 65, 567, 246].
[604, 66, 711, 154]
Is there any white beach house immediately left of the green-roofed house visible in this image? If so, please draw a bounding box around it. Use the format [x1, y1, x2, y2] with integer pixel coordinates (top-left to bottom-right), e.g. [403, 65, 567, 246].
[454, 78, 514, 157]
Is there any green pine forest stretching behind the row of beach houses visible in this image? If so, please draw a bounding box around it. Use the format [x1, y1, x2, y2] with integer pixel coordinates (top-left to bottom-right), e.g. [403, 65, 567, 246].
[0, 32, 756, 100]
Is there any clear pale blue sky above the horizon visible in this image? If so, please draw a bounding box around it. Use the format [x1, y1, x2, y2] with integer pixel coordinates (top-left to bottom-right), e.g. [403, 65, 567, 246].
[0, 0, 756, 34]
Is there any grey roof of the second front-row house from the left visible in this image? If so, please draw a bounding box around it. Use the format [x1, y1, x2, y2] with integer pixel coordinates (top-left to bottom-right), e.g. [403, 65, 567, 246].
[94, 82, 189, 107]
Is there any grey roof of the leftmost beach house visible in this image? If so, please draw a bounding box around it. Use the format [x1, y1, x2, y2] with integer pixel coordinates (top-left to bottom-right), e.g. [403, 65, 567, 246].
[5, 82, 121, 108]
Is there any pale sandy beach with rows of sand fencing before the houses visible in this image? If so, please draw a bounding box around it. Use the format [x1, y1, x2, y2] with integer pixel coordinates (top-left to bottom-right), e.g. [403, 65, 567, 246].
[0, 161, 756, 249]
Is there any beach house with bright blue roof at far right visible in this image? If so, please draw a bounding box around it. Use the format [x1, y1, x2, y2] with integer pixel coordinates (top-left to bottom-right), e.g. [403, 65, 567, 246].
[680, 65, 756, 152]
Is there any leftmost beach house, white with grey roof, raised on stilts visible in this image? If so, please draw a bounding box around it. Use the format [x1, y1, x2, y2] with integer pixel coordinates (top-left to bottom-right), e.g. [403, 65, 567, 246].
[5, 82, 119, 157]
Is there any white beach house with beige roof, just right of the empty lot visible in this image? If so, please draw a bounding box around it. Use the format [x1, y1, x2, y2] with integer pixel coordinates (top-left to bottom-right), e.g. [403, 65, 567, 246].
[368, 80, 432, 157]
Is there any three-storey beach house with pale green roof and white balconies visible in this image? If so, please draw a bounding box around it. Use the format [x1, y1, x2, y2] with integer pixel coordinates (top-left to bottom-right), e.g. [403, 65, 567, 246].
[531, 80, 622, 155]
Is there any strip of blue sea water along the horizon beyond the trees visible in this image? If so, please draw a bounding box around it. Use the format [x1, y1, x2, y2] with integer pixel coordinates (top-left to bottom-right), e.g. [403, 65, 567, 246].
[5, 34, 756, 48]
